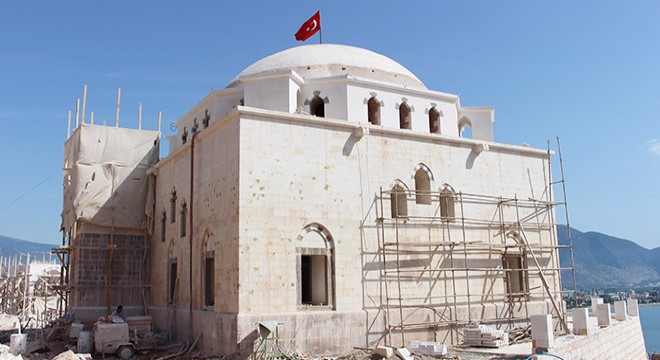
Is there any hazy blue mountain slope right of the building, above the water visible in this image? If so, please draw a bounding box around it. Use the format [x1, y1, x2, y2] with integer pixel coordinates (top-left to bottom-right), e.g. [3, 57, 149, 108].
[557, 226, 660, 289]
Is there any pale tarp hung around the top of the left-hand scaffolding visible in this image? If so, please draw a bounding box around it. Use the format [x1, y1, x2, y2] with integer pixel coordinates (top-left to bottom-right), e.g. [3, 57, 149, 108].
[62, 125, 160, 230]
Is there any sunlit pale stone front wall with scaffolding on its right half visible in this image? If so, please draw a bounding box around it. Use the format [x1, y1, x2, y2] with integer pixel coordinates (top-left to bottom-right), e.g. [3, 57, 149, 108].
[238, 108, 558, 348]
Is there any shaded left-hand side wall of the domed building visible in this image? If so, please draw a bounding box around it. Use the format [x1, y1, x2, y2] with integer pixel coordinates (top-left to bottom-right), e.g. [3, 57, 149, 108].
[152, 115, 239, 313]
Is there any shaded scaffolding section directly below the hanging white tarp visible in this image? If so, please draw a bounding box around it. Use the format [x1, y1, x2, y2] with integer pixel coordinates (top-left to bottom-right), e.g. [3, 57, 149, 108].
[52, 221, 151, 314]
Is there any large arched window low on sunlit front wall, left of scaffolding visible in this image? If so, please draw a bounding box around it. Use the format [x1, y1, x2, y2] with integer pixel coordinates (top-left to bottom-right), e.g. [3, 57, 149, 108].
[296, 223, 335, 307]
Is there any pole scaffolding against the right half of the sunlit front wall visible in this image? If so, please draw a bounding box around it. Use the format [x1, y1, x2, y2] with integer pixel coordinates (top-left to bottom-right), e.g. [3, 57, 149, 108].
[377, 139, 576, 344]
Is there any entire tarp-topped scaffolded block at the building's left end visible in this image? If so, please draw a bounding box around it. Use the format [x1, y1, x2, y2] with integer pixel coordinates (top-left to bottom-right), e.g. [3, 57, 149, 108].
[52, 122, 160, 320]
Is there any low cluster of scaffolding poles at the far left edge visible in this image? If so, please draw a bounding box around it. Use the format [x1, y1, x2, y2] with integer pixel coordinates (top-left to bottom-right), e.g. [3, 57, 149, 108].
[0, 253, 63, 327]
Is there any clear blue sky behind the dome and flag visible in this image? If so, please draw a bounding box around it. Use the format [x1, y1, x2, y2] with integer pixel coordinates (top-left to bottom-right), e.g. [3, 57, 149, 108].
[0, 0, 660, 248]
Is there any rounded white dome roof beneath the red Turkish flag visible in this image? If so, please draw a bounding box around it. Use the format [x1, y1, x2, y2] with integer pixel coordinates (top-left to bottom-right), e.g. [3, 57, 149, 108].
[227, 44, 426, 89]
